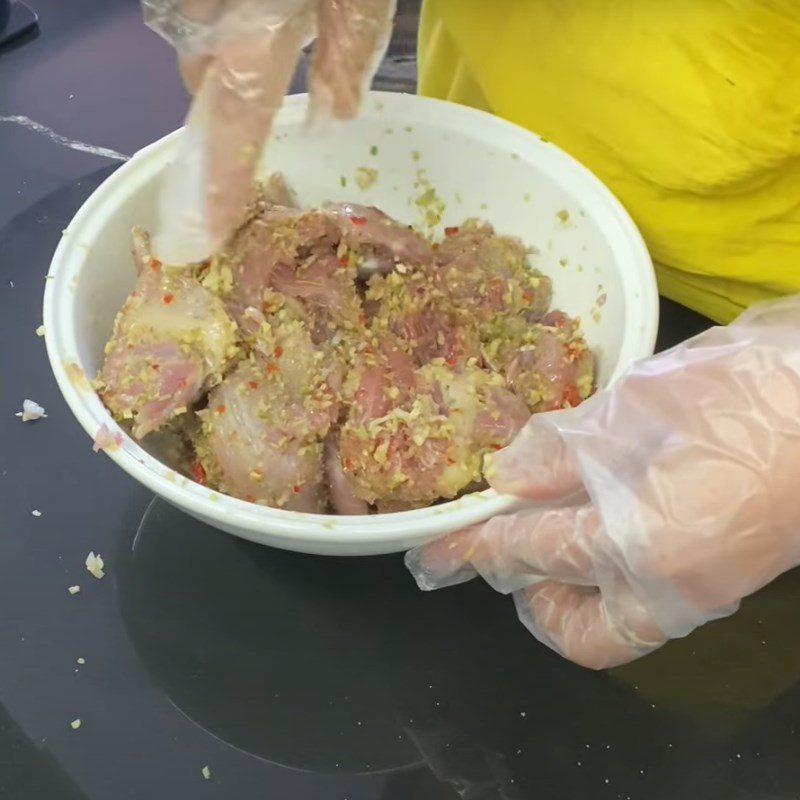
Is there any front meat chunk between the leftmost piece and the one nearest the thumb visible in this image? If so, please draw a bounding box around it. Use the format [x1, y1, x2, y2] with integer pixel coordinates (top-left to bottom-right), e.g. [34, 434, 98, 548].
[195, 314, 341, 512]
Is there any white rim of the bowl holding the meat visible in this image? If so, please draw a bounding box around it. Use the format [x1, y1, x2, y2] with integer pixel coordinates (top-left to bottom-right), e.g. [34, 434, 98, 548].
[43, 92, 659, 549]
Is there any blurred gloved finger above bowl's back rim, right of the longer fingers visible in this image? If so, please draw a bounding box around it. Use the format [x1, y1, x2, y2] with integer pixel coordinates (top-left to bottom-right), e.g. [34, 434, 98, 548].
[309, 0, 395, 119]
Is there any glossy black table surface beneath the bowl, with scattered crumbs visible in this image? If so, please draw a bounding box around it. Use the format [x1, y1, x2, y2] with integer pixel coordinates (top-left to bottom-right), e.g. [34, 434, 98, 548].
[0, 0, 800, 800]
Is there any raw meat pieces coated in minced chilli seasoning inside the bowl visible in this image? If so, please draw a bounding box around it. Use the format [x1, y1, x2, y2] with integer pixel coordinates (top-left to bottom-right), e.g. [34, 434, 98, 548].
[97, 169, 595, 516]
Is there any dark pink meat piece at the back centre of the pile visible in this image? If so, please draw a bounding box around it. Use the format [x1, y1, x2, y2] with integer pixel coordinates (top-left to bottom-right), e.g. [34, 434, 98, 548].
[325, 203, 435, 277]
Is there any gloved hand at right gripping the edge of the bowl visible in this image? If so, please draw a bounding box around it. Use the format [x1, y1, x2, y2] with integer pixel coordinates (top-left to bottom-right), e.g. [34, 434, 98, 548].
[406, 296, 800, 669]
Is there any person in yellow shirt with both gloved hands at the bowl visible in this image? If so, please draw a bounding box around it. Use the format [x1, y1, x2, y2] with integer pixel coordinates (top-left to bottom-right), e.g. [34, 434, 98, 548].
[143, 0, 800, 668]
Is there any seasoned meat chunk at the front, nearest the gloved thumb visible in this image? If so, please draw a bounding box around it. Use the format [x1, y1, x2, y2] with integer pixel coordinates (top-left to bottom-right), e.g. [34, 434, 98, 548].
[340, 351, 530, 510]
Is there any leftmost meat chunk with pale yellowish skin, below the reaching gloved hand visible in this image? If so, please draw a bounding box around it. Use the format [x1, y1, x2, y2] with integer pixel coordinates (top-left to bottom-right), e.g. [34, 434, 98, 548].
[98, 250, 236, 438]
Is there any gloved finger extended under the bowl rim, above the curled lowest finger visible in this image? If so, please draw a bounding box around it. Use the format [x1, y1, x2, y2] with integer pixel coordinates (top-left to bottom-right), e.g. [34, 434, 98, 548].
[406, 506, 601, 594]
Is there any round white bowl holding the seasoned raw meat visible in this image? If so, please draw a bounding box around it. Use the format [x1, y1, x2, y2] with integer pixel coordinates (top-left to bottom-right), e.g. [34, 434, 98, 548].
[44, 93, 658, 555]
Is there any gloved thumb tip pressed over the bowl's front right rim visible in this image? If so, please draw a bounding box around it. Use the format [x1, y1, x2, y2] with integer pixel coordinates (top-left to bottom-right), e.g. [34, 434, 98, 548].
[486, 418, 583, 502]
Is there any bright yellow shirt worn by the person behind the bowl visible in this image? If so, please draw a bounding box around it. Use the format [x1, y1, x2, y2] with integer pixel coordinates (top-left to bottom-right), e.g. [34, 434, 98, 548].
[419, 0, 800, 322]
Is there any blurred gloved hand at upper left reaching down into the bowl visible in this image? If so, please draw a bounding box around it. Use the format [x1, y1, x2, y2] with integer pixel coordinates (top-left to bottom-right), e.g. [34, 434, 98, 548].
[142, 0, 395, 264]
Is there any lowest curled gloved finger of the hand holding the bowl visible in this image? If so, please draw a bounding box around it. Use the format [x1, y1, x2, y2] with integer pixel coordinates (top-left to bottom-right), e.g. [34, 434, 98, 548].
[514, 581, 666, 669]
